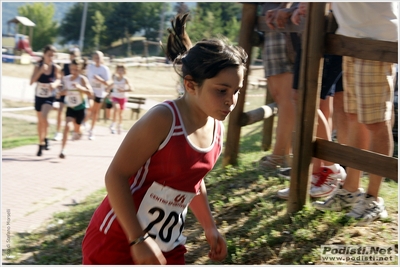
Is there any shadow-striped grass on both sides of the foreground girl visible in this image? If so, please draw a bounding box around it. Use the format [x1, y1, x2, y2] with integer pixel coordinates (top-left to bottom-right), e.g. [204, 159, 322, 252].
[3, 111, 398, 265]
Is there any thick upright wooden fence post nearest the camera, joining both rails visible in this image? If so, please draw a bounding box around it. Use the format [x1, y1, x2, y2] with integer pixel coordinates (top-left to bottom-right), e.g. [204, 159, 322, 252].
[287, 2, 326, 213]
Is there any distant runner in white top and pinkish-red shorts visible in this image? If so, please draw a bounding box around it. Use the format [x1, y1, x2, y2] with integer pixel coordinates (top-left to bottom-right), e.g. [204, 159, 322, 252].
[110, 65, 132, 134]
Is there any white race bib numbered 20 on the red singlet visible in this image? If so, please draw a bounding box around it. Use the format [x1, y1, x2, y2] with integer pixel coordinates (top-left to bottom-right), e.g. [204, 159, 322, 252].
[137, 182, 196, 252]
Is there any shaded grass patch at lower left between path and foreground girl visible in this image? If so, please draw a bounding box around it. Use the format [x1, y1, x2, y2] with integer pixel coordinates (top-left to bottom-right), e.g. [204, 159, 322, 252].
[3, 190, 105, 265]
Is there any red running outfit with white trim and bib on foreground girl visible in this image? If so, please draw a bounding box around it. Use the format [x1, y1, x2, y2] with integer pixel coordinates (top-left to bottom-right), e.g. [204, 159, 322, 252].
[82, 101, 223, 264]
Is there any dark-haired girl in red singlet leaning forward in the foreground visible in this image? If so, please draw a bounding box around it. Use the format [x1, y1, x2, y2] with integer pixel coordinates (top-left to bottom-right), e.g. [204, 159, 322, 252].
[82, 14, 247, 264]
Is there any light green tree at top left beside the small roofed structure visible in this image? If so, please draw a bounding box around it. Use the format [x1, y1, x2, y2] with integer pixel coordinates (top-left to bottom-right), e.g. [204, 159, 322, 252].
[18, 3, 58, 51]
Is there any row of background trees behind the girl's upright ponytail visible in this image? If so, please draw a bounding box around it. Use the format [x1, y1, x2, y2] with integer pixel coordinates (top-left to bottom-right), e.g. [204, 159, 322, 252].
[60, 2, 241, 55]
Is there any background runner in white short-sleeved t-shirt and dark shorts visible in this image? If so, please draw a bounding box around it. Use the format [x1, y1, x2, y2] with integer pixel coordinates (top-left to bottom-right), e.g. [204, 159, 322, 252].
[87, 51, 110, 140]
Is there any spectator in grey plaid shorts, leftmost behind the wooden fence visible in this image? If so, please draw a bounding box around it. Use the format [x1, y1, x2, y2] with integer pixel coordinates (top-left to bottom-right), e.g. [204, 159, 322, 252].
[259, 3, 295, 171]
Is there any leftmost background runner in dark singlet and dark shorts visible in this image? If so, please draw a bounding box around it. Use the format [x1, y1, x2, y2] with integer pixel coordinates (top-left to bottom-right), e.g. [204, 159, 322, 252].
[30, 45, 61, 156]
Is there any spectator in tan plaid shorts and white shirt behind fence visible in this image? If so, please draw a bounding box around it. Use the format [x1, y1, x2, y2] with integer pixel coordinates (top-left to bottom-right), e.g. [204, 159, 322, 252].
[313, 2, 398, 225]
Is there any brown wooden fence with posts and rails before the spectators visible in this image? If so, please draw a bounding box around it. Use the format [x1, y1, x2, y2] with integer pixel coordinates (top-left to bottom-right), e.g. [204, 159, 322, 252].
[223, 2, 398, 213]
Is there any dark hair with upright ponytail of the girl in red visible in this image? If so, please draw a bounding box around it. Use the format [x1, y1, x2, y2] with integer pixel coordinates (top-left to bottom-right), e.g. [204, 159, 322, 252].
[165, 16, 248, 86]
